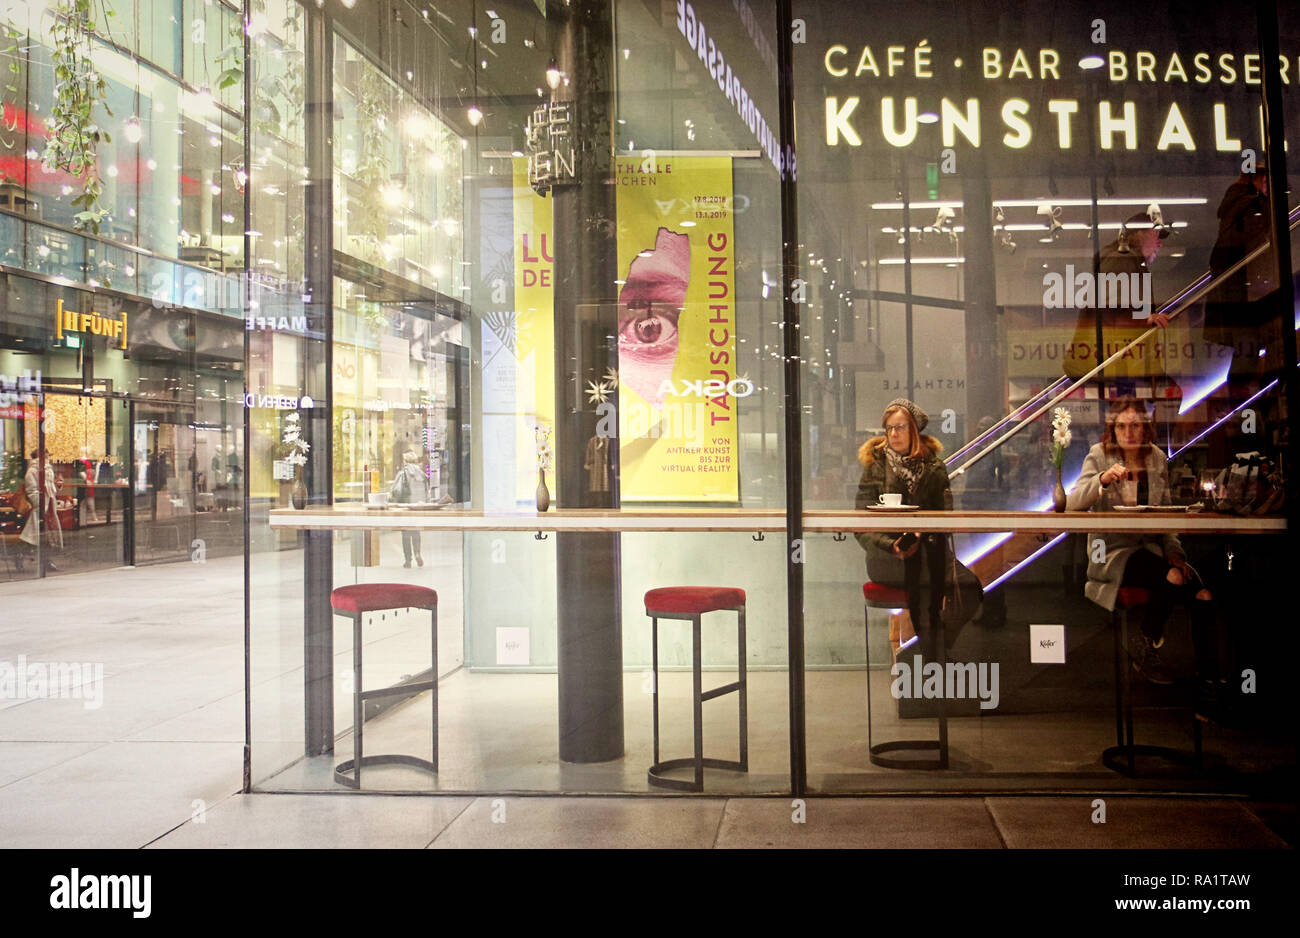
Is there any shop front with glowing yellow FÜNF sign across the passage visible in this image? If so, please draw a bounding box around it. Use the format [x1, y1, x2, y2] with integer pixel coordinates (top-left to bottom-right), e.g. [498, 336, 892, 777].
[0, 266, 243, 578]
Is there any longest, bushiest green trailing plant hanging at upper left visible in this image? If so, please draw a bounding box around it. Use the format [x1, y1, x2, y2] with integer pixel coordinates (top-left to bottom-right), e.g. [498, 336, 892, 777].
[40, 0, 113, 234]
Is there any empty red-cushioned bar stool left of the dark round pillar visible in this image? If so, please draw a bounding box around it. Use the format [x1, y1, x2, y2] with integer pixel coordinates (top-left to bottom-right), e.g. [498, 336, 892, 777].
[329, 583, 438, 789]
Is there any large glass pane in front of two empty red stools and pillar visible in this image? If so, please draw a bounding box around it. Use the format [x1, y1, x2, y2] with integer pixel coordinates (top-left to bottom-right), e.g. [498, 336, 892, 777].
[248, 3, 789, 791]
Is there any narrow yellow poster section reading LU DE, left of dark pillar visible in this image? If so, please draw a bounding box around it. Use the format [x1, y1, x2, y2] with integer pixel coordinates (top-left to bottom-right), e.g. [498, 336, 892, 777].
[514, 157, 558, 501]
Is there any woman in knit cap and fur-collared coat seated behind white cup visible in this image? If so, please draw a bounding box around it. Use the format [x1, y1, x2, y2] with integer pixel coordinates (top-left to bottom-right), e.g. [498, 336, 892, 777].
[855, 398, 953, 657]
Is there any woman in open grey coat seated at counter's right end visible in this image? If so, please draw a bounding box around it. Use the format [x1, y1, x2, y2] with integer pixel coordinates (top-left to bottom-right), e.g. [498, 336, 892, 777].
[1066, 398, 1218, 703]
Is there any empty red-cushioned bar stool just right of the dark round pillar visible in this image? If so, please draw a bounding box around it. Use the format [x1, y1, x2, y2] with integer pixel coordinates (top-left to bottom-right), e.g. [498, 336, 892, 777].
[645, 586, 749, 791]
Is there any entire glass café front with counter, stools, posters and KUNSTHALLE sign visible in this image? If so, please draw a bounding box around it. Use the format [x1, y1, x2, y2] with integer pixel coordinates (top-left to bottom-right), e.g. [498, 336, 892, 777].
[226, 0, 1300, 794]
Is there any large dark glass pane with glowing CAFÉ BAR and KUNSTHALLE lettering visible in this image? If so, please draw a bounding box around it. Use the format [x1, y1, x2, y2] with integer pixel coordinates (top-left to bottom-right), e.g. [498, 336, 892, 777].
[794, 3, 1295, 790]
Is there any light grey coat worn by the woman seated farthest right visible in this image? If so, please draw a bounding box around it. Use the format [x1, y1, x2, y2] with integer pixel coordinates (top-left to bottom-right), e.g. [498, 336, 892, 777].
[1065, 443, 1184, 611]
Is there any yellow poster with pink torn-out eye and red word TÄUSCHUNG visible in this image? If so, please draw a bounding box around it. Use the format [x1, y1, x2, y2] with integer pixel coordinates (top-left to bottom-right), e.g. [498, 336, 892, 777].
[618, 153, 751, 503]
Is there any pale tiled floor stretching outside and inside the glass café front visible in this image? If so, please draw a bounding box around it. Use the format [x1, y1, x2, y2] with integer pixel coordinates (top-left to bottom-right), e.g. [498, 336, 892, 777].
[0, 557, 1296, 848]
